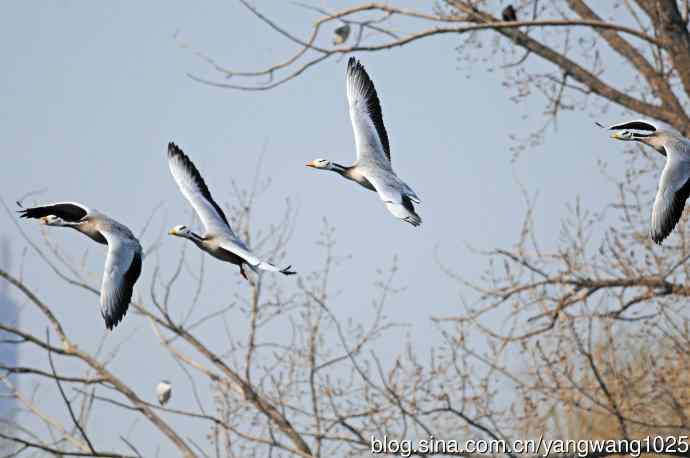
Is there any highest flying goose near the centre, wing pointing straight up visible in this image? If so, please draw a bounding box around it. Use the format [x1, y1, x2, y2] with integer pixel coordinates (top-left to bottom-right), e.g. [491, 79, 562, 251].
[307, 57, 422, 226]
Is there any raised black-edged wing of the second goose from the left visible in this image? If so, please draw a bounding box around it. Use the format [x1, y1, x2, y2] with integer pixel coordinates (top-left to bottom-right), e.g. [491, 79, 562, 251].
[168, 142, 235, 237]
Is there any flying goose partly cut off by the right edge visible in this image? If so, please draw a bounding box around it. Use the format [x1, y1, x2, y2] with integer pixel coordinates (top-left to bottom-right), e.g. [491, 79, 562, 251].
[601, 121, 690, 245]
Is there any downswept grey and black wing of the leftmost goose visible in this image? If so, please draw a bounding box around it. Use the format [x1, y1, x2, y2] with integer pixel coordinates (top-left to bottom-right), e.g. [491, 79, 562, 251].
[100, 230, 142, 329]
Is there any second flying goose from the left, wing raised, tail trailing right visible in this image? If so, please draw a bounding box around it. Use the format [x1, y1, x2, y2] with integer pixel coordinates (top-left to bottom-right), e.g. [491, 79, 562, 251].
[168, 143, 296, 280]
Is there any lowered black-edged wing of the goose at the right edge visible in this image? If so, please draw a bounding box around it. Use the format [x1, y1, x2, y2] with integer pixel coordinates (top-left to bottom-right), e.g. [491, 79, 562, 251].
[650, 154, 690, 244]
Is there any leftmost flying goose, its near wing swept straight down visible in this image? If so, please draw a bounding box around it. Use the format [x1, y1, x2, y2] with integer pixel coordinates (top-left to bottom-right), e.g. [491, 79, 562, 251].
[19, 202, 142, 329]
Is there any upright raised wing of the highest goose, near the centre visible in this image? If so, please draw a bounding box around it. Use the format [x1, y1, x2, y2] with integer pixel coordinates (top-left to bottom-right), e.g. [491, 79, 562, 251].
[347, 57, 391, 165]
